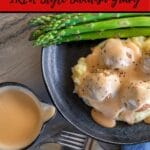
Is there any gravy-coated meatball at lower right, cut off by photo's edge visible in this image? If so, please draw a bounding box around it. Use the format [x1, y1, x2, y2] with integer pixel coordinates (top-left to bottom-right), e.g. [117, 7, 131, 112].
[122, 81, 150, 111]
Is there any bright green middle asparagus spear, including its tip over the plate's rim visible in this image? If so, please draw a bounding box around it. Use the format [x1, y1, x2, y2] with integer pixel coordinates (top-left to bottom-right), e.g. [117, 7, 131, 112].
[34, 17, 150, 45]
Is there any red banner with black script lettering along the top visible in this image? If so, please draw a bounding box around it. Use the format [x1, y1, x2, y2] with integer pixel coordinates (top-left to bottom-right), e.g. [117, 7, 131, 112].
[0, 0, 150, 12]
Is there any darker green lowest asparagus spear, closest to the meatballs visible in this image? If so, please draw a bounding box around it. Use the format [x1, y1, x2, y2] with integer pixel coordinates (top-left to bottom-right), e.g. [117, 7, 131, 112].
[33, 28, 150, 47]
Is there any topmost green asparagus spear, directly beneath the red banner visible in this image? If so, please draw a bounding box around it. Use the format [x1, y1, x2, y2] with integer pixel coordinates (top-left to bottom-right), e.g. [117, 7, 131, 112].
[29, 13, 150, 26]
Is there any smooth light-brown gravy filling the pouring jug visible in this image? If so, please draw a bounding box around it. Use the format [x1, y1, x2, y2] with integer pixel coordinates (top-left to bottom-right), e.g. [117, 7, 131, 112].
[0, 88, 41, 146]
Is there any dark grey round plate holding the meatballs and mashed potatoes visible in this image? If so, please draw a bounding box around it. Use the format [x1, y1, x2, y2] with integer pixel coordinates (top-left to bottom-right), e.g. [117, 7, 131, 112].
[42, 41, 150, 144]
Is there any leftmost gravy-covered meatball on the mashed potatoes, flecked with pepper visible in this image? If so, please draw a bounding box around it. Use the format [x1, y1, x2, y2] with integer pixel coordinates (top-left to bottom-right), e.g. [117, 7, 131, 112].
[78, 70, 120, 102]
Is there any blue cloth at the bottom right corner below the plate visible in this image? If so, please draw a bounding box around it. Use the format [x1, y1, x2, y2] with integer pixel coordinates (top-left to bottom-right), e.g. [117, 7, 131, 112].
[121, 142, 150, 150]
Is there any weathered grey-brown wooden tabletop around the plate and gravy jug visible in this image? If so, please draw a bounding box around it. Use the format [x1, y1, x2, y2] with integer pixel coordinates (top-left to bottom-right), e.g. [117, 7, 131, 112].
[0, 13, 69, 149]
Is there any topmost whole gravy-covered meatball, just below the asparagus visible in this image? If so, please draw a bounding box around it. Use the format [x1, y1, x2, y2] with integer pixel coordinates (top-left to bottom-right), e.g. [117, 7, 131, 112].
[102, 39, 135, 69]
